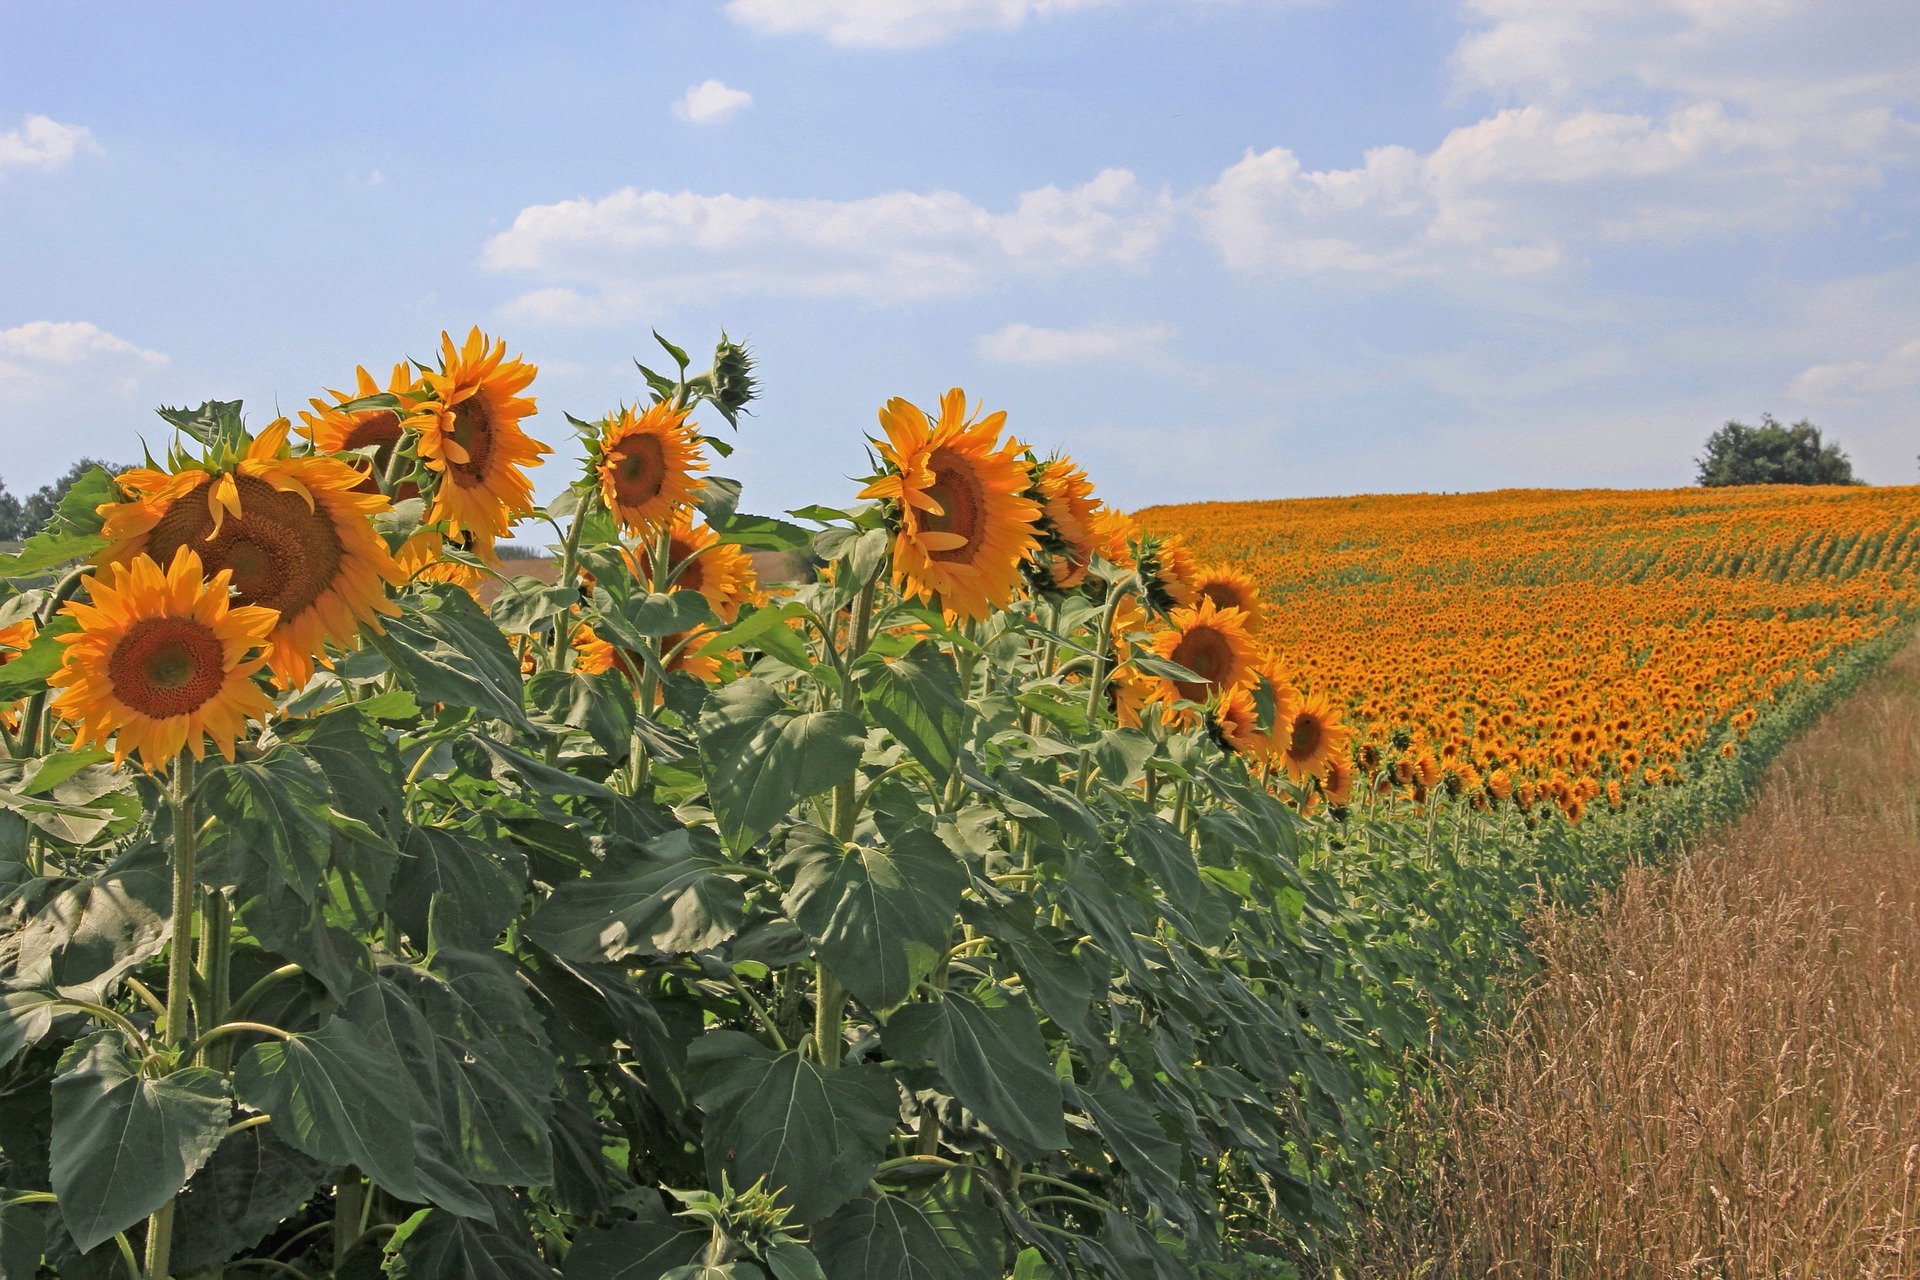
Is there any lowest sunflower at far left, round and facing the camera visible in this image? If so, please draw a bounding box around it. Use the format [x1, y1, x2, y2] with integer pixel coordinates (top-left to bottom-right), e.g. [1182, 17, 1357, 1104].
[46, 547, 278, 771]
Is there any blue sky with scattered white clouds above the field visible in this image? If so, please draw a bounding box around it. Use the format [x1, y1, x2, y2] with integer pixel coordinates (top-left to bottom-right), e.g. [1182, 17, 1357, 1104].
[0, 0, 1920, 510]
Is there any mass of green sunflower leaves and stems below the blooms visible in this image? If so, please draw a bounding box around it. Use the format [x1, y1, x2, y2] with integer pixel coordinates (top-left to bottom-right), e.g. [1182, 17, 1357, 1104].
[0, 344, 1912, 1280]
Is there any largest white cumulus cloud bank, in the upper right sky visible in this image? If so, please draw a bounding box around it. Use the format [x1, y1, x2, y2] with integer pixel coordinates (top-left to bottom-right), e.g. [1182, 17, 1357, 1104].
[1198, 0, 1920, 276]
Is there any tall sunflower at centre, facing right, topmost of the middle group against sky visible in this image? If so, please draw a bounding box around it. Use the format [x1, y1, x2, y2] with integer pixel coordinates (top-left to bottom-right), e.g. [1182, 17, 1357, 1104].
[860, 388, 1041, 620]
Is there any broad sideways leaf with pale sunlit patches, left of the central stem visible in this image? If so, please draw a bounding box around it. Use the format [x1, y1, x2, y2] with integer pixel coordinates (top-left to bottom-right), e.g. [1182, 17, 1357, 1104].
[526, 854, 745, 963]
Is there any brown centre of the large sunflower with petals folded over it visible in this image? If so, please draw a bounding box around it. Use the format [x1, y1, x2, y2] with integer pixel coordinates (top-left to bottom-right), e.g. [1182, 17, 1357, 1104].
[146, 476, 346, 622]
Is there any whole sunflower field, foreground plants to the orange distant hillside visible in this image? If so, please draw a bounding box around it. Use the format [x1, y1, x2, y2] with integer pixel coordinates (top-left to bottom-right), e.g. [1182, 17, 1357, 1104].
[0, 330, 1920, 1280]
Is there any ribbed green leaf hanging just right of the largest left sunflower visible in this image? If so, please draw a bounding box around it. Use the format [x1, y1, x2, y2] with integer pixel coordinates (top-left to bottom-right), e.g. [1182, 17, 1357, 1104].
[372, 585, 534, 731]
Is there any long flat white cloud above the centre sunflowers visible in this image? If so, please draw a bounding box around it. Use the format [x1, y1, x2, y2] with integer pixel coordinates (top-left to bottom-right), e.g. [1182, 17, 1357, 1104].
[480, 169, 1171, 320]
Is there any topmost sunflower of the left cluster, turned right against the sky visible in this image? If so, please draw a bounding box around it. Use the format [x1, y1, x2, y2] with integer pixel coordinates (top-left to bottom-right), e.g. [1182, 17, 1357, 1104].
[405, 328, 549, 537]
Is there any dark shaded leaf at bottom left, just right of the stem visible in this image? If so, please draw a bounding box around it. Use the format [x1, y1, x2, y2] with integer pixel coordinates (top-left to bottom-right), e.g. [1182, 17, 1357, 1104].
[173, 1126, 326, 1274]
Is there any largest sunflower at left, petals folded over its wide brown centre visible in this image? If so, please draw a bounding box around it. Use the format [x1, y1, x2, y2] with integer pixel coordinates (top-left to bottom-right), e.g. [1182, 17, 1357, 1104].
[100, 418, 401, 687]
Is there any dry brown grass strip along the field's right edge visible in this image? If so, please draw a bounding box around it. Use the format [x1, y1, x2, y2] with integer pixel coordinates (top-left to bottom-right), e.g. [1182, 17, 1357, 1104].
[1367, 647, 1920, 1280]
